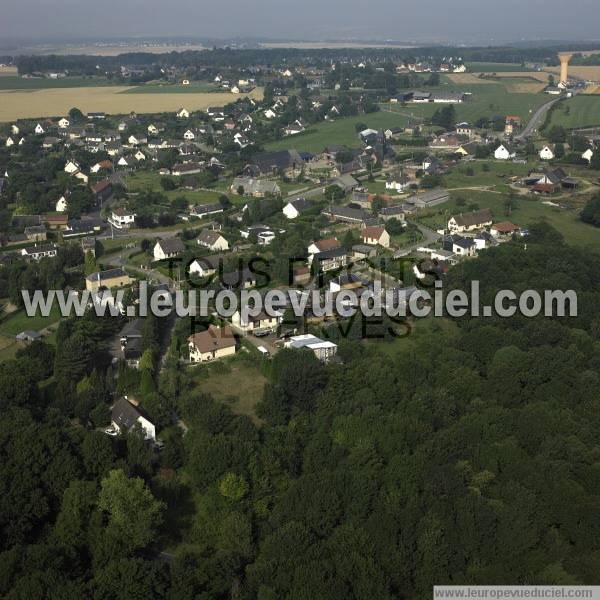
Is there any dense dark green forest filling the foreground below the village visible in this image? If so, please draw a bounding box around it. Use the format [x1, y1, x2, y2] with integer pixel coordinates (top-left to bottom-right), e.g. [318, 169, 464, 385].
[0, 224, 600, 600]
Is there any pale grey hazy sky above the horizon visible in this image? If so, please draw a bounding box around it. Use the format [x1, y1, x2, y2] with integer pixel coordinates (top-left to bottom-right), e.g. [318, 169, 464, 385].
[0, 0, 600, 43]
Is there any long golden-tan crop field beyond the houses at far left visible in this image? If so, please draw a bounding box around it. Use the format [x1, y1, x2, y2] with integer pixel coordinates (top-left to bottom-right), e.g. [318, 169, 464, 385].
[0, 86, 262, 122]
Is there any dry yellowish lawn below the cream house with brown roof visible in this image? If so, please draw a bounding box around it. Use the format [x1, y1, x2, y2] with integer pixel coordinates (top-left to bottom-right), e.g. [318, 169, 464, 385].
[195, 357, 267, 423]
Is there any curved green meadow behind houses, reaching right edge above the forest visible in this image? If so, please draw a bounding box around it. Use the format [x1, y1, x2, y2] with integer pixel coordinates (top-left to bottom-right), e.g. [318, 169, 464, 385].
[417, 190, 600, 251]
